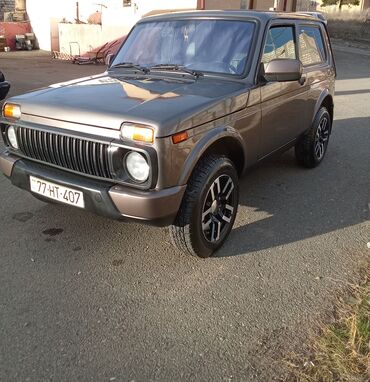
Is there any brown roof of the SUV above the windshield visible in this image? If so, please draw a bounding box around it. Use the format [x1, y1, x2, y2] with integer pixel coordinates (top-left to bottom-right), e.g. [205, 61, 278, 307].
[139, 9, 321, 23]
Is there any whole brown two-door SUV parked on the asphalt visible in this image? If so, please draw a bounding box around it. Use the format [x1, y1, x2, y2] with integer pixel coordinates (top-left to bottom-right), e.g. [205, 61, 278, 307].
[0, 11, 335, 257]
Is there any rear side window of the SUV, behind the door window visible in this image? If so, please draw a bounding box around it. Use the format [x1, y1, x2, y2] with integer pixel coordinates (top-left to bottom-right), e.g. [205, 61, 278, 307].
[299, 25, 326, 66]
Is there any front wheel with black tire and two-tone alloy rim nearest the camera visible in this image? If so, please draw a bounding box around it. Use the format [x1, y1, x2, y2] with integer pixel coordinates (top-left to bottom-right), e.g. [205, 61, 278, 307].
[170, 155, 239, 258]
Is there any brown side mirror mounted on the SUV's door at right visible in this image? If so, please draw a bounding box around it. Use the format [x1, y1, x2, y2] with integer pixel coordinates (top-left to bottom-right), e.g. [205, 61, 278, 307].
[263, 58, 302, 82]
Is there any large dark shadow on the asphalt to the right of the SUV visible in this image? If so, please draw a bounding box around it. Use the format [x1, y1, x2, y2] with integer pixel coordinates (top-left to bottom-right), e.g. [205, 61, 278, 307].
[217, 117, 370, 257]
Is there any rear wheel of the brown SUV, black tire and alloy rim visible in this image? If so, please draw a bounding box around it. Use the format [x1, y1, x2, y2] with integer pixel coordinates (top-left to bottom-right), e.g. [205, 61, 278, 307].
[295, 107, 331, 168]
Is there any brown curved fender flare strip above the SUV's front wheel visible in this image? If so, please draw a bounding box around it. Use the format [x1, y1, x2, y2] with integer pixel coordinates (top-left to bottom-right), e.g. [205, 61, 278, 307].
[177, 126, 247, 185]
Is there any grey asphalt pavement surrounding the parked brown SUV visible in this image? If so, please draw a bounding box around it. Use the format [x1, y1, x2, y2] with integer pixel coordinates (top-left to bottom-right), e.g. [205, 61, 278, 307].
[0, 48, 370, 382]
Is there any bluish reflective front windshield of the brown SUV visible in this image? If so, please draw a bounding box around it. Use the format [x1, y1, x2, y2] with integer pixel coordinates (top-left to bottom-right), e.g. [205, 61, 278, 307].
[112, 19, 254, 75]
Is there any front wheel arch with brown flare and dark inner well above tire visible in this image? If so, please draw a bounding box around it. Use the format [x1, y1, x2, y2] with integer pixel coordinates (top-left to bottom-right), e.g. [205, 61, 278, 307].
[178, 127, 246, 184]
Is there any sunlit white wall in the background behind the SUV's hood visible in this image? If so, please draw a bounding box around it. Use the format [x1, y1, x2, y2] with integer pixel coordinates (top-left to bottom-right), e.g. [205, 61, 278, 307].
[27, 0, 197, 53]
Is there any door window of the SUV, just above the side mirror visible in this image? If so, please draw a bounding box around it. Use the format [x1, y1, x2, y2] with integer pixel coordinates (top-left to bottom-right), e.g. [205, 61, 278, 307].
[262, 26, 297, 64]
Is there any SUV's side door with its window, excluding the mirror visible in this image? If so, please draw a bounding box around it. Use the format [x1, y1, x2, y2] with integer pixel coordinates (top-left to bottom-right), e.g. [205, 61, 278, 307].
[259, 21, 309, 159]
